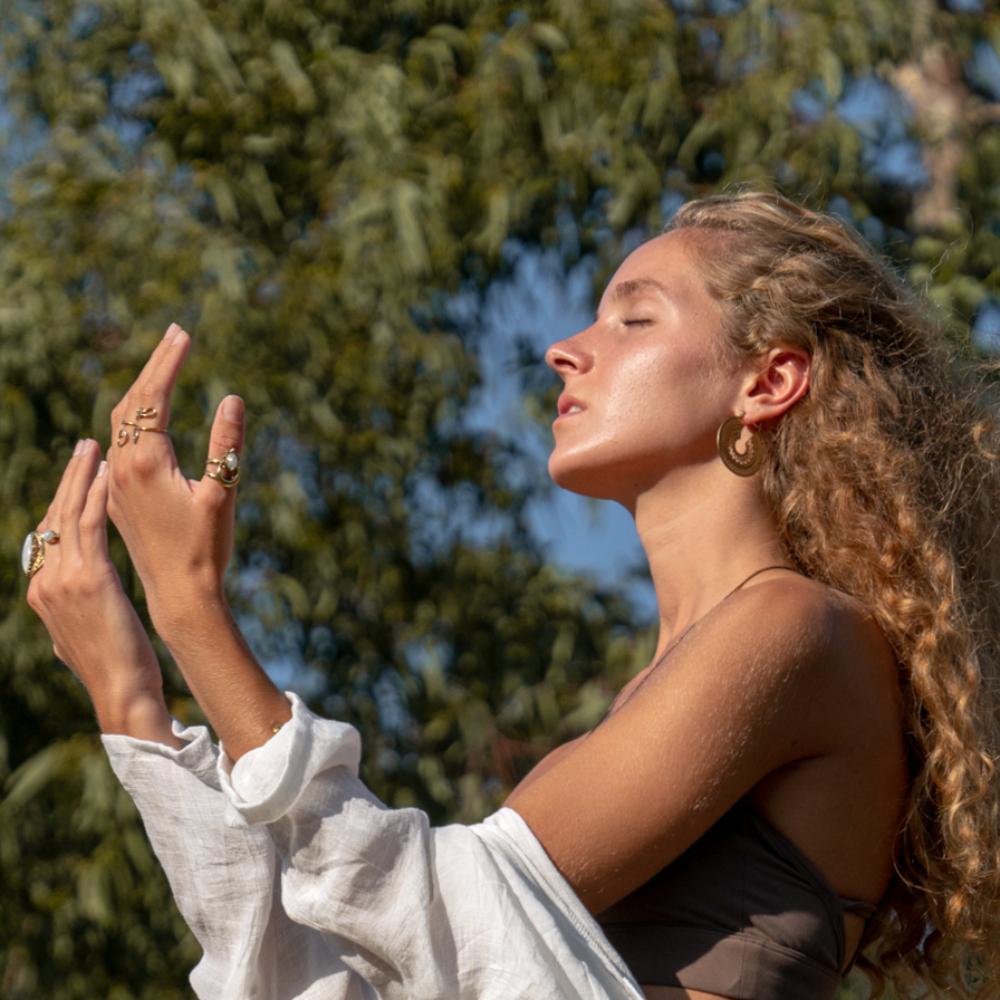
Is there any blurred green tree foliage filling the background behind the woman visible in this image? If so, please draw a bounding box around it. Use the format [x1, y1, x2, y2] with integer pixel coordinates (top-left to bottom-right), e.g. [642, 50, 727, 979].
[0, 0, 1000, 1000]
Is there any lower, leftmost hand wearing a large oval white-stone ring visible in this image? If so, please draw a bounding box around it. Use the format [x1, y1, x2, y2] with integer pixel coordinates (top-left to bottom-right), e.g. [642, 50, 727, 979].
[28, 441, 163, 732]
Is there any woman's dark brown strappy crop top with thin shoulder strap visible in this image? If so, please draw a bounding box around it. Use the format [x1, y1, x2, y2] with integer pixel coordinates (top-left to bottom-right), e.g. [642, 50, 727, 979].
[596, 566, 877, 1000]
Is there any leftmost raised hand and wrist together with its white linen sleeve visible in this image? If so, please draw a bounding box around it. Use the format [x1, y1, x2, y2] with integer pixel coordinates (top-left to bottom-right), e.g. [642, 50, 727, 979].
[25, 441, 324, 1000]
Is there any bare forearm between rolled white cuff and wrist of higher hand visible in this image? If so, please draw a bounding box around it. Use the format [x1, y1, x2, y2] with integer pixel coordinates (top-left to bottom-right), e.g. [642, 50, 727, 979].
[150, 588, 291, 761]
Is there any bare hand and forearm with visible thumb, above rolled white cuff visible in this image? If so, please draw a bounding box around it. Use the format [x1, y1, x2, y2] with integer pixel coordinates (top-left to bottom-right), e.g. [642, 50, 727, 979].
[108, 325, 290, 760]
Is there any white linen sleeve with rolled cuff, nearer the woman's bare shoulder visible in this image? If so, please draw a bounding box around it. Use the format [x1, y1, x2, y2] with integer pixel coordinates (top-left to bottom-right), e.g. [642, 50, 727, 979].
[216, 693, 642, 1000]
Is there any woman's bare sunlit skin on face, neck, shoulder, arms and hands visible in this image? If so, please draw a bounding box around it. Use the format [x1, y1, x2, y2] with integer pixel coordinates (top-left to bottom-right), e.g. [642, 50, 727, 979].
[29, 233, 906, 1000]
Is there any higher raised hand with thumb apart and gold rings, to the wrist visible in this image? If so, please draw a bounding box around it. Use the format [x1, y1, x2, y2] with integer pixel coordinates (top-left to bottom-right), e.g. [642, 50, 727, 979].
[108, 324, 243, 620]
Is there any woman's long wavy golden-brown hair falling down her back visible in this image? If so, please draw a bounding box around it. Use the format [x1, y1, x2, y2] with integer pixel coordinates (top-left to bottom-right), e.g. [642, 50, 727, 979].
[668, 193, 1000, 998]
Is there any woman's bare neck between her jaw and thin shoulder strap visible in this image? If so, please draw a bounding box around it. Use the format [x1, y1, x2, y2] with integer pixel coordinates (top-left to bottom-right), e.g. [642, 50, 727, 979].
[632, 462, 791, 661]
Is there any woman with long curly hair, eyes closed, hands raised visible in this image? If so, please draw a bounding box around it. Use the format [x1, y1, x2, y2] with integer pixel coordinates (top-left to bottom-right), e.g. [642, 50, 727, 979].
[28, 194, 1000, 1000]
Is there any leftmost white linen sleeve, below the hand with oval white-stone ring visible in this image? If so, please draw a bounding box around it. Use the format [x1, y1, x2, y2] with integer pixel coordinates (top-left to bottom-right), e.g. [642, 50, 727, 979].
[102, 720, 376, 1000]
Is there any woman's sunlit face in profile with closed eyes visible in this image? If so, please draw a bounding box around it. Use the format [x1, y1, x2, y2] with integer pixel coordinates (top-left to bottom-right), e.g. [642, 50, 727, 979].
[545, 232, 740, 509]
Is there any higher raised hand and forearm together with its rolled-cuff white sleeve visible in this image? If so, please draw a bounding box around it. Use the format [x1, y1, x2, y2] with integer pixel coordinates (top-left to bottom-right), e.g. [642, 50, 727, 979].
[94, 328, 640, 1000]
